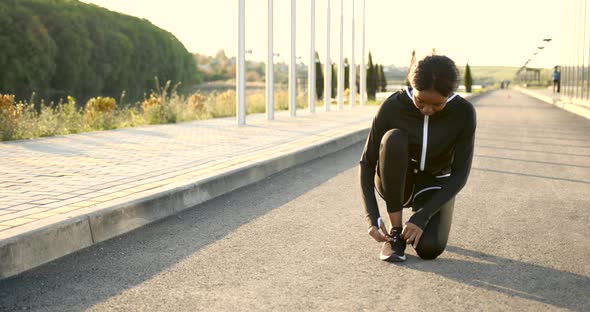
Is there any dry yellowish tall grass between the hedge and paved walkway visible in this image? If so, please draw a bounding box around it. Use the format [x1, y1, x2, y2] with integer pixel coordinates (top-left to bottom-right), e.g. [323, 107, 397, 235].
[0, 79, 314, 141]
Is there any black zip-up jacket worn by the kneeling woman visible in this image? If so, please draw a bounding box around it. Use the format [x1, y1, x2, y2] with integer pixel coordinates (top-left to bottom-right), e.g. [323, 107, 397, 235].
[360, 88, 476, 229]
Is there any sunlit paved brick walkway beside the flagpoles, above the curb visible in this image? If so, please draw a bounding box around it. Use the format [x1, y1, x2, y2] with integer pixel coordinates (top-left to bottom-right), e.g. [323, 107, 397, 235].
[0, 106, 377, 277]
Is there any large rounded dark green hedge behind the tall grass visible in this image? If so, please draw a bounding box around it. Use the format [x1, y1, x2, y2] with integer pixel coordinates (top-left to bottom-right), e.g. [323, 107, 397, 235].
[0, 0, 199, 103]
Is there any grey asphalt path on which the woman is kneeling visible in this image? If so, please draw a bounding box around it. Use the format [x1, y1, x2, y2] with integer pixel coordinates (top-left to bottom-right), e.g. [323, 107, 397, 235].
[0, 90, 590, 311]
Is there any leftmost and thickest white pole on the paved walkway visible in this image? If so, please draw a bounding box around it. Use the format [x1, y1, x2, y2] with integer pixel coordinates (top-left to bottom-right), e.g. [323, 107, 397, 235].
[236, 0, 246, 125]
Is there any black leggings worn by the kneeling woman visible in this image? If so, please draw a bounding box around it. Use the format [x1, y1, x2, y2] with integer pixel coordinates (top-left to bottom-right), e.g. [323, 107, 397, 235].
[375, 129, 455, 259]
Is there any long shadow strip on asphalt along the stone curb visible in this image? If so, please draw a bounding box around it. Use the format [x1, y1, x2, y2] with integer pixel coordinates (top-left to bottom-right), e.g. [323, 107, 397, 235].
[0, 143, 362, 311]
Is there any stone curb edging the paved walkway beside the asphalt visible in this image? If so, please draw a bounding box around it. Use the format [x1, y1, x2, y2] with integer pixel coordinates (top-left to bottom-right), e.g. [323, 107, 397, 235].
[0, 128, 369, 279]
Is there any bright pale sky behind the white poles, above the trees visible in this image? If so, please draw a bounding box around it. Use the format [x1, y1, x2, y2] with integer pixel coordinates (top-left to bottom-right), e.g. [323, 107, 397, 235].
[83, 0, 562, 67]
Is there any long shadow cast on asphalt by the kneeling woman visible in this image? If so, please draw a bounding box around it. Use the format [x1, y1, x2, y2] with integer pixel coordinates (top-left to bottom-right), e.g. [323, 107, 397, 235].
[405, 246, 590, 311]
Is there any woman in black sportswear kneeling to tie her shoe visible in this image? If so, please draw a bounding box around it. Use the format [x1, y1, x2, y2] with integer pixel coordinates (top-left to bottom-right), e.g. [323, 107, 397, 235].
[360, 55, 476, 262]
